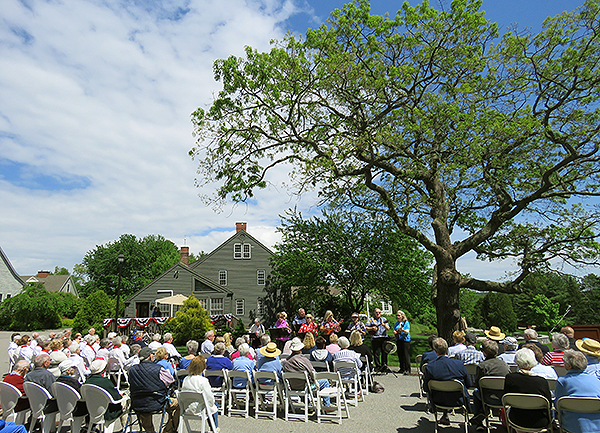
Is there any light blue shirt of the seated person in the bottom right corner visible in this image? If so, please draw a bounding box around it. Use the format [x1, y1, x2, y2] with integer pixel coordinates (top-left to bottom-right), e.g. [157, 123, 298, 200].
[555, 370, 600, 433]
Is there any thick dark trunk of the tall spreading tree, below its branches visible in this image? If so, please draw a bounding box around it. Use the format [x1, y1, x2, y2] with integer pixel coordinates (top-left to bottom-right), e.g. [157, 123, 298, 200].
[434, 268, 460, 346]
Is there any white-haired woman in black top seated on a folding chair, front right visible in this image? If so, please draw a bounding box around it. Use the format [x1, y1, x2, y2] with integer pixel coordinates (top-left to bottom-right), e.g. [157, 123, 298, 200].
[504, 348, 552, 428]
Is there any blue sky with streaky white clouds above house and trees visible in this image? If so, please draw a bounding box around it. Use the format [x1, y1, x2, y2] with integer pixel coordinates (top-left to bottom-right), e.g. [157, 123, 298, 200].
[0, 0, 583, 279]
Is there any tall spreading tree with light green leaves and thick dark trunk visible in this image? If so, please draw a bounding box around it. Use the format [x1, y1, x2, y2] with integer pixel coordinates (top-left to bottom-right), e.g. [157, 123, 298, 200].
[190, 0, 600, 338]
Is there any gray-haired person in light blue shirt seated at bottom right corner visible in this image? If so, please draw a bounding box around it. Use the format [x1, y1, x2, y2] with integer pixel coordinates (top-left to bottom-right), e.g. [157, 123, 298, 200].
[555, 350, 600, 433]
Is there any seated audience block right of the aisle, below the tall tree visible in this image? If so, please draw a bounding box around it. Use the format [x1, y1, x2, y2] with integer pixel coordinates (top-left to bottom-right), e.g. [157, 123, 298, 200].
[420, 327, 600, 433]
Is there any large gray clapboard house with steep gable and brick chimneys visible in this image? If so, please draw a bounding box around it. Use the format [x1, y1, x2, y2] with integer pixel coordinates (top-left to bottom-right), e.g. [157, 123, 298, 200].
[125, 223, 273, 325]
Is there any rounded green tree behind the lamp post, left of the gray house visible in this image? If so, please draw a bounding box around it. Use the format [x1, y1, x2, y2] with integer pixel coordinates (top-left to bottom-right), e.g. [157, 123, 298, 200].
[75, 234, 181, 298]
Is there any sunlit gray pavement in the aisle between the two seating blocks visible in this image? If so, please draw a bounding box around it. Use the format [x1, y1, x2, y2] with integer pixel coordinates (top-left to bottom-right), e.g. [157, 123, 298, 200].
[0, 331, 505, 433]
